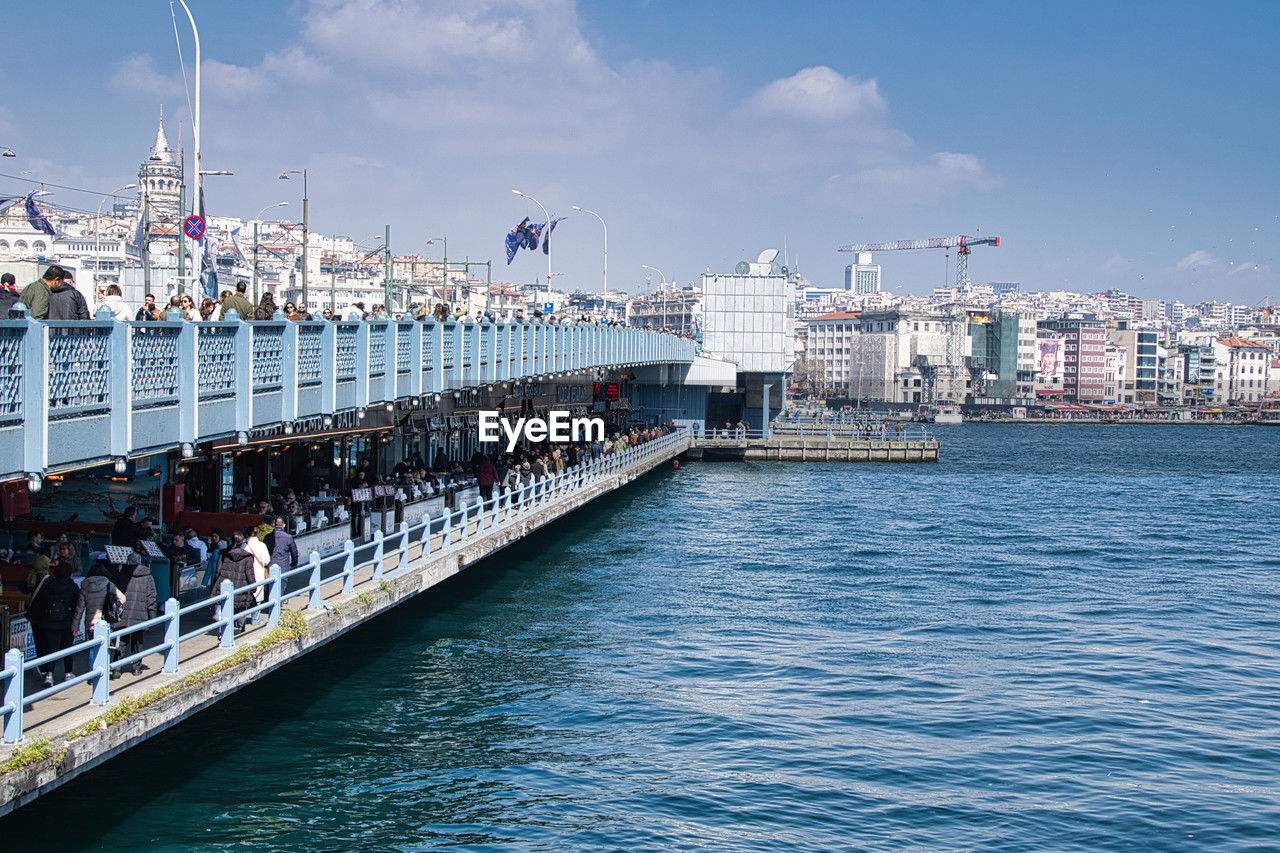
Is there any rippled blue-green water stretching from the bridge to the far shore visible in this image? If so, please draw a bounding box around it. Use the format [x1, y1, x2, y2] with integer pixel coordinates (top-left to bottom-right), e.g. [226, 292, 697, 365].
[10, 425, 1280, 850]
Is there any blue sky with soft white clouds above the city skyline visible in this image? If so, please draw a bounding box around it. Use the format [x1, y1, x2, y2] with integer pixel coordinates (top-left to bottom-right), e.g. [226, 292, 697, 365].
[0, 0, 1280, 305]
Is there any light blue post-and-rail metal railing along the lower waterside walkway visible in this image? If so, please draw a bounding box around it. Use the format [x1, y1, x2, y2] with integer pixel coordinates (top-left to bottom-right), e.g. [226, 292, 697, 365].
[0, 429, 690, 744]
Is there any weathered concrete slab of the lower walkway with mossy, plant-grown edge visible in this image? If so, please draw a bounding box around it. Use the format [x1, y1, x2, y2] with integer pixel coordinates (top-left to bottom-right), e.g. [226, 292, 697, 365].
[0, 433, 690, 815]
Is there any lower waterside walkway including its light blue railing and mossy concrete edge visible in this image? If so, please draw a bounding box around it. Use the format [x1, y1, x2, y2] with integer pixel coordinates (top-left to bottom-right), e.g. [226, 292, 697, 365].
[0, 430, 690, 815]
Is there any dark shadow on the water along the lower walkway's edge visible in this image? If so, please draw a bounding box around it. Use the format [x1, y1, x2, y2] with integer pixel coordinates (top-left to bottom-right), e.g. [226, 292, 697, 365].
[0, 458, 671, 849]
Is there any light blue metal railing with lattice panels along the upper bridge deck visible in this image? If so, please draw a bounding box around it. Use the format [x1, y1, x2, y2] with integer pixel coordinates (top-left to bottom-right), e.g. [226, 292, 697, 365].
[0, 315, 695, 479]
